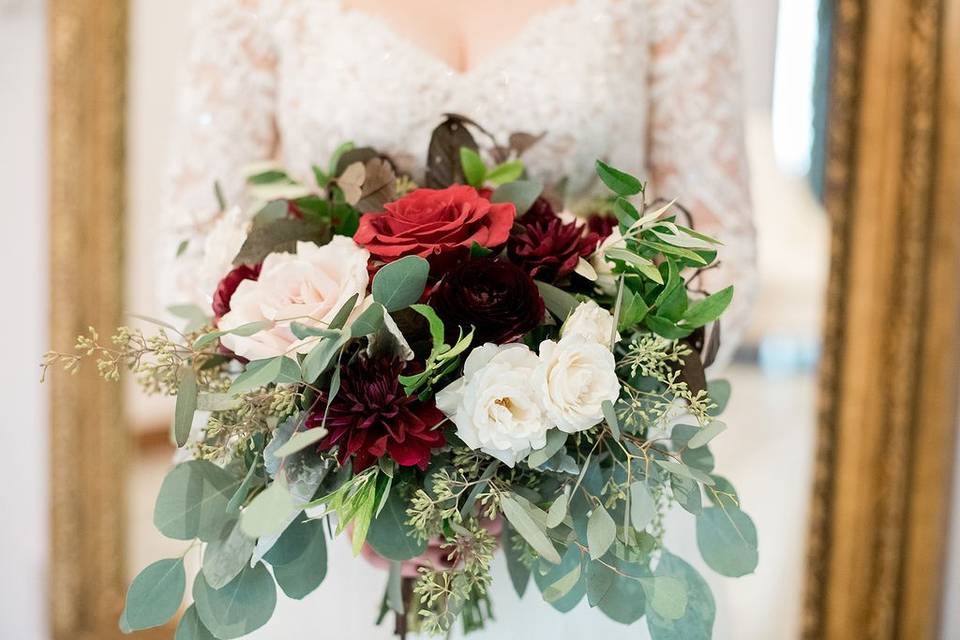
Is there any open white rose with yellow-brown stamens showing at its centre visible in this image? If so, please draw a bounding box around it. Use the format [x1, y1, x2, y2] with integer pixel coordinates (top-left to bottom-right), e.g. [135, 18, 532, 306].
[436, 343, 550, 467]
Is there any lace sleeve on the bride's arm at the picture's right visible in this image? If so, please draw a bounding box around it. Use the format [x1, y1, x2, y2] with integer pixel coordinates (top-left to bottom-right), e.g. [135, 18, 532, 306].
[649, 0, 757, 362]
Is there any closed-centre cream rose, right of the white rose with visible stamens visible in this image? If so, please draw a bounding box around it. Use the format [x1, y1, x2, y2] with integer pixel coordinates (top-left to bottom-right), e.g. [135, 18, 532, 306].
[534, 335, 620, 433]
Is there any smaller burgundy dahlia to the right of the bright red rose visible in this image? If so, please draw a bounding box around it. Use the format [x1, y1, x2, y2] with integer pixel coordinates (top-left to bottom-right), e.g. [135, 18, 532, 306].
[507, 205, 599, 282]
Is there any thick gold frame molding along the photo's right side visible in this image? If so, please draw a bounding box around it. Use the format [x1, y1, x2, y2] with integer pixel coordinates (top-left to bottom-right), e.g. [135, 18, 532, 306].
[803, 0, 960, 640]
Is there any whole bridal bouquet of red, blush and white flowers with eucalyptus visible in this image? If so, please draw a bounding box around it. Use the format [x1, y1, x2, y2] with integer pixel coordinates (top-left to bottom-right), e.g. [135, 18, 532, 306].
[45, 116, 757, 640]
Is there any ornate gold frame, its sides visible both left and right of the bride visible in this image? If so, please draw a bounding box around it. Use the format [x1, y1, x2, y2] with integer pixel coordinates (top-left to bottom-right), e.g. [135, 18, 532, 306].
[48, 0, 960, 640]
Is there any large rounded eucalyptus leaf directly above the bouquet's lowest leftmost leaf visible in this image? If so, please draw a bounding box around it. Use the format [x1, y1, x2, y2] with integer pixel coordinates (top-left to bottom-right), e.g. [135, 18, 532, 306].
[153, 460, 240, 542]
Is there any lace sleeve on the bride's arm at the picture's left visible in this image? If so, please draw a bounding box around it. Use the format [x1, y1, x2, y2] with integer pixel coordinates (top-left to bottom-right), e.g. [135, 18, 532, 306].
[158, 0, 277, 307]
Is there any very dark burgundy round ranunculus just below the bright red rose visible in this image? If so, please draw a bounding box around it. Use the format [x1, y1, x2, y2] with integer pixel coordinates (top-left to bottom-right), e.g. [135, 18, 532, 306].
[430, 259, 543, 345]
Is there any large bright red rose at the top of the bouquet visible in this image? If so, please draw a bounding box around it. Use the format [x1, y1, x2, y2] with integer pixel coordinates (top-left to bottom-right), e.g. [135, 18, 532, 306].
[353, 185, 516, 267]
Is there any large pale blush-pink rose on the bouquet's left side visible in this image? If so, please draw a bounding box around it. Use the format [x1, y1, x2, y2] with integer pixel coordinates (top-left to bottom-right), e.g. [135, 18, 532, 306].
[218, 236, 370, 360]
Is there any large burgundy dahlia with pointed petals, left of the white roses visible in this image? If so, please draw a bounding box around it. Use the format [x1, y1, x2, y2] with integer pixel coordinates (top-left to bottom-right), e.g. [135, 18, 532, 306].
[306, 355, 446, 471]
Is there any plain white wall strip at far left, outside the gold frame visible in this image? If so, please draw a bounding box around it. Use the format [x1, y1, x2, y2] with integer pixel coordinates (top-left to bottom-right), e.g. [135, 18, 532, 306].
[0, 0, 48, 640]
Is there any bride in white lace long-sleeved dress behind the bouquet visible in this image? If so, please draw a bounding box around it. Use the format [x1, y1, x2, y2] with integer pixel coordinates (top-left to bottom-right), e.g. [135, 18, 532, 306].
[164, 0, 754, 638]
